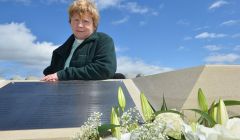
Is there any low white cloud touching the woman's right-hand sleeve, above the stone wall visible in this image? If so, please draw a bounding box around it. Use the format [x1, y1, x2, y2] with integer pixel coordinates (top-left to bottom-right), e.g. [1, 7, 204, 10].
[118, 56, 173, 78]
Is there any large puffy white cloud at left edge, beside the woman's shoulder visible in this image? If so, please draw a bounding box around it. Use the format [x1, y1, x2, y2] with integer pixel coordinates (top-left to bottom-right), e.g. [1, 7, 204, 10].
[0, 23, 57, 77]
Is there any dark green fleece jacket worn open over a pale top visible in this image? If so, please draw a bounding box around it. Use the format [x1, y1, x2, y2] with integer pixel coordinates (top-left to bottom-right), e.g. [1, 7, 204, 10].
[43, 32, 117, 80]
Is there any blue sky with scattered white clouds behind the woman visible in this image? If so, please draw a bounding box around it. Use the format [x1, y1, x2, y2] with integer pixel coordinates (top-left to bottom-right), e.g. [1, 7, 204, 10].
[0, 0, 240, 79]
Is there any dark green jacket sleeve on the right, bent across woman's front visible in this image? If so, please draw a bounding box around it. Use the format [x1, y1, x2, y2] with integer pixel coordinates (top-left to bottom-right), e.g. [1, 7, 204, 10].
[57, 36, 117, 80]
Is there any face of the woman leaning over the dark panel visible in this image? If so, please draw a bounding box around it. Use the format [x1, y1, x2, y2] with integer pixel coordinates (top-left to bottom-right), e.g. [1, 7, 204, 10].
[70, 13, 95, 40]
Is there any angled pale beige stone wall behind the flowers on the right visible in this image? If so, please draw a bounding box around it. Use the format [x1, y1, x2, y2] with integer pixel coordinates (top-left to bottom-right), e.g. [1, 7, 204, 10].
[133, 65, 240, 119]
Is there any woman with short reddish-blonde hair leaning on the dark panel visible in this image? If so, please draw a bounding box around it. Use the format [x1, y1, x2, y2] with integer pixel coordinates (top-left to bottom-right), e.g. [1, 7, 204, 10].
[42, 0, 117, 81]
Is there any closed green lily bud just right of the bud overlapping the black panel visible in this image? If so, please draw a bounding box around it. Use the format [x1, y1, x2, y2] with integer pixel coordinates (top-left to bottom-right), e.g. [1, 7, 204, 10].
[140, 93, 154, 122]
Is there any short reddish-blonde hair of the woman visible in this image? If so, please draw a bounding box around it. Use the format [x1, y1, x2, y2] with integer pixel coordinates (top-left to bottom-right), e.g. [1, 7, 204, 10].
[68, 0, 99, 29]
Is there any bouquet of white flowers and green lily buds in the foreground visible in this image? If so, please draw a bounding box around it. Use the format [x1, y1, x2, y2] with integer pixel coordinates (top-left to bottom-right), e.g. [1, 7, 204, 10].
[72, 87, 240, 140]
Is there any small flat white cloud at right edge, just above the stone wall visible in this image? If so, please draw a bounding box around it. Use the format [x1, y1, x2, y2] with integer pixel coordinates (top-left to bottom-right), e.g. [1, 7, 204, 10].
[204, 53, 240, 64]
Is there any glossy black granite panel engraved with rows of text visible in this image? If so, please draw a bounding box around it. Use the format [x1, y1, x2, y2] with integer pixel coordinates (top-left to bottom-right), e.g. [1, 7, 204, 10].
[0, 81, 135, 130]
